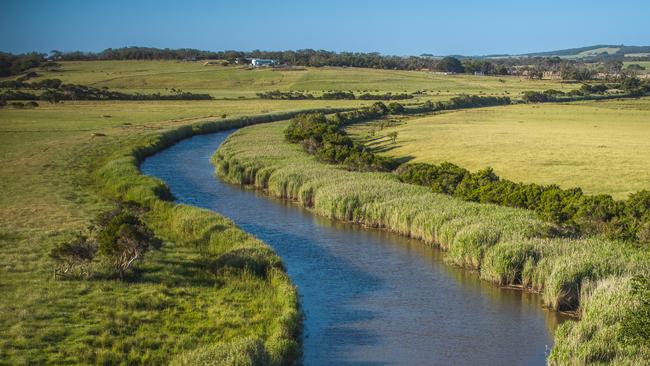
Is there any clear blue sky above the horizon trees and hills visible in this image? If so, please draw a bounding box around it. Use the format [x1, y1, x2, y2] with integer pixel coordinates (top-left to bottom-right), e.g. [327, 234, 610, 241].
[0, 0, 650, 55]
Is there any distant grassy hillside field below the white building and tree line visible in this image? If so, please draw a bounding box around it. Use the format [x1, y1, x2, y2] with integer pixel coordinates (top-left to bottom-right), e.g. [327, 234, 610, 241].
[27, 61, 578, 99]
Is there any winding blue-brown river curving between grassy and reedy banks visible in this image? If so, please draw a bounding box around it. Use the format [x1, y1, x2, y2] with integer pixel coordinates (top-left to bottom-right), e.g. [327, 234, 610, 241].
[141, 131, 561, 365]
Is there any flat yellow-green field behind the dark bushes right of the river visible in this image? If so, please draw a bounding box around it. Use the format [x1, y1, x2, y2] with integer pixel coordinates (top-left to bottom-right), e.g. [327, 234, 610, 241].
[350, 98, 650, 199]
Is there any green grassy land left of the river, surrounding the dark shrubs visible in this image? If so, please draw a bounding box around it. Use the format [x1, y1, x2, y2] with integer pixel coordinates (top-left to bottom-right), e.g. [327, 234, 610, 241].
[0, 102, 360, 365]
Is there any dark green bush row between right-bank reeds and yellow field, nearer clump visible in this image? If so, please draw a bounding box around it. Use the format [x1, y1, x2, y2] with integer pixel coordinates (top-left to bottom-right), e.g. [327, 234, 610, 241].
[396, 162, 650, 246]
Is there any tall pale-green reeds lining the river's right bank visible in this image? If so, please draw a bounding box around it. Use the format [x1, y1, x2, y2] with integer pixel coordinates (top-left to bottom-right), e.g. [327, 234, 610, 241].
[213, 122, 650, 364]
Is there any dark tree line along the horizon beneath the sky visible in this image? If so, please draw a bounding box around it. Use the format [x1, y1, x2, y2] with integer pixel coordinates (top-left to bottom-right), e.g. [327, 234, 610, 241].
[0, 47, 632, 80]
